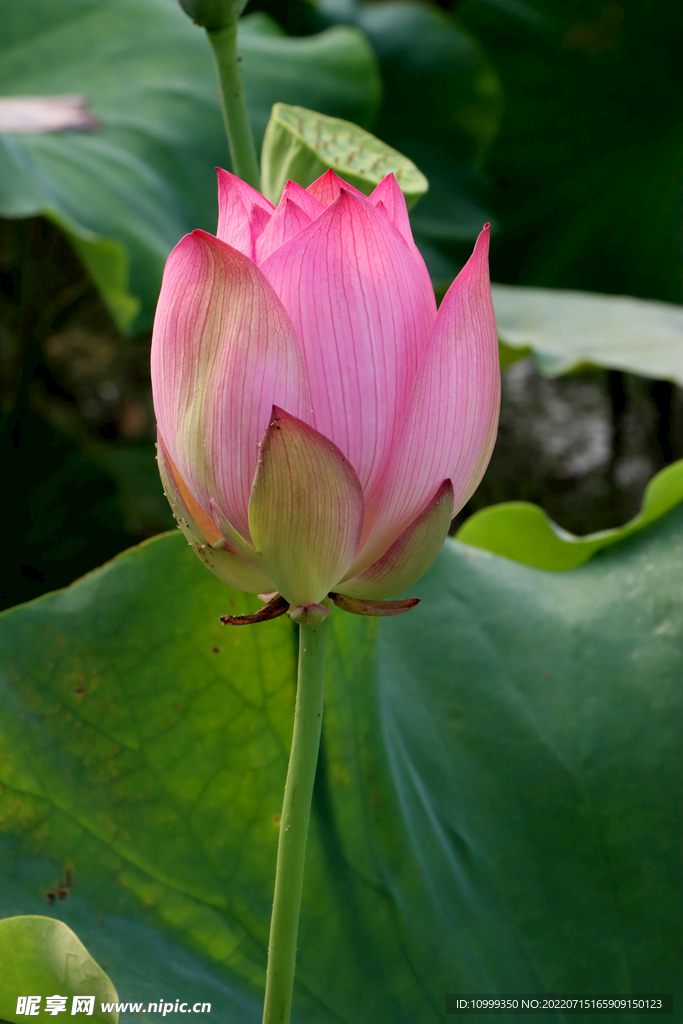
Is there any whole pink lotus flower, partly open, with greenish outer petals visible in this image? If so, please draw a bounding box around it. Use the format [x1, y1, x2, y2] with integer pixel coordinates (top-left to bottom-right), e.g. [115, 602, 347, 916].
[152, 170, 500, 622]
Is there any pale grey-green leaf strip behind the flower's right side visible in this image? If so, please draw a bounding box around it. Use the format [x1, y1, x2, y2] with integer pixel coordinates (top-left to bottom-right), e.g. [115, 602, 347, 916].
[492, 285, 683, 384]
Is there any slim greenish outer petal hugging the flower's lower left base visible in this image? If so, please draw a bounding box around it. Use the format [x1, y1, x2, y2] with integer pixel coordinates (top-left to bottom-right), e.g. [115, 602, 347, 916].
[157, 435, 272, 594]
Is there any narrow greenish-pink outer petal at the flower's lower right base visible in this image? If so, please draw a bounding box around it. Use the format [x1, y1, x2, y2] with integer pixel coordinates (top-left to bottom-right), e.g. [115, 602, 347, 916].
[335, 480, 453, 600]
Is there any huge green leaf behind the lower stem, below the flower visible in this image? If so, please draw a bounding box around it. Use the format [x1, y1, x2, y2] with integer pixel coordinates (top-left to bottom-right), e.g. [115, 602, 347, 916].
[0, 516, 683, 1024]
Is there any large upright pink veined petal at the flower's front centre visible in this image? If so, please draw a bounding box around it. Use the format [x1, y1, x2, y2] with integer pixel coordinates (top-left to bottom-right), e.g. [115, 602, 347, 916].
[261, 187, 436, 517]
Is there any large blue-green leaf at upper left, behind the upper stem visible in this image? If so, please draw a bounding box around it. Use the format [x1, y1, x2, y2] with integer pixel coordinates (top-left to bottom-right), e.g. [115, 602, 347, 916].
[0, 0, 380, 327]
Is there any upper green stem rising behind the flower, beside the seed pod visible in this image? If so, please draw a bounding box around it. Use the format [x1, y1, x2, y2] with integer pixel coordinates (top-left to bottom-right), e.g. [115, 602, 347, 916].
[207, 18, 261, 190]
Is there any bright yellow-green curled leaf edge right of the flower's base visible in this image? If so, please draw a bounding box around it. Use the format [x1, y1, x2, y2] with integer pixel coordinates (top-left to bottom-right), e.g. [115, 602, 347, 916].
[458, 460, 683, 571]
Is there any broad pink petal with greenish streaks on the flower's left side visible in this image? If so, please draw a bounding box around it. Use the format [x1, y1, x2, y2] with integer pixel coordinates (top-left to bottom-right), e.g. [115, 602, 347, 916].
[152, 231, 310, 540]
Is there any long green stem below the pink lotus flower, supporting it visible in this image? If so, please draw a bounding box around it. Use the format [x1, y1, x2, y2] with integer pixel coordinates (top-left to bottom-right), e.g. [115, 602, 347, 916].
[263, 622, 328, 1024]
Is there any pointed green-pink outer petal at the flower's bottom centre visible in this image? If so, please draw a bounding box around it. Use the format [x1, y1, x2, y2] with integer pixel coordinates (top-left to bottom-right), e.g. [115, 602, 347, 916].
[249, 407, 364, 605]
